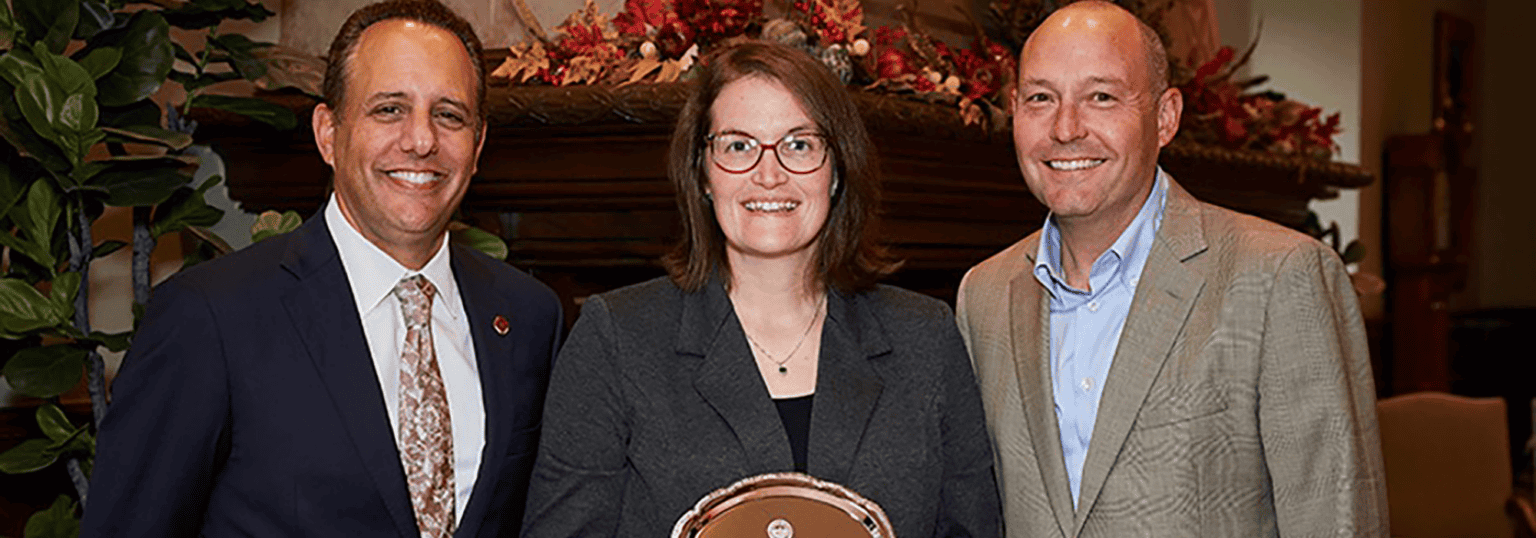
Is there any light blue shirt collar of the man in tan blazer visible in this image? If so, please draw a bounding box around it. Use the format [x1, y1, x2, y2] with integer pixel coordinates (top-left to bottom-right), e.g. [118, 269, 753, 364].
[1034, 166, 1169, 298]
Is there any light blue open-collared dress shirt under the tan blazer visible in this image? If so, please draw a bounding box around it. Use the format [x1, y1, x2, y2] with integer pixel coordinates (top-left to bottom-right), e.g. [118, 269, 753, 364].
[1035, 168, 1167, 509]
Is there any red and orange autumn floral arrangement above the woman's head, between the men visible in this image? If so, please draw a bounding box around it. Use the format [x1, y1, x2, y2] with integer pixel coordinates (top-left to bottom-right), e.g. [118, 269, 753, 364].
[492, 0, 1014, 128]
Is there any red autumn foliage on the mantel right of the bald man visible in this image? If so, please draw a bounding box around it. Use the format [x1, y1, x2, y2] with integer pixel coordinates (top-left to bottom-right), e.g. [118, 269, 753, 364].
[1180, 42, 1339, 161]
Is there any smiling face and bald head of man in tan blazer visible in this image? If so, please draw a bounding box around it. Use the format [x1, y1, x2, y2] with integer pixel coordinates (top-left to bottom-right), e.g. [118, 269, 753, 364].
[1014, 3, 1183, 224]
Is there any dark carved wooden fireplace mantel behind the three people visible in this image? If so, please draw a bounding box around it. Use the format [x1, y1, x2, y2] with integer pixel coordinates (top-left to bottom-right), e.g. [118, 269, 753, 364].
[194, 85, 1372, 307]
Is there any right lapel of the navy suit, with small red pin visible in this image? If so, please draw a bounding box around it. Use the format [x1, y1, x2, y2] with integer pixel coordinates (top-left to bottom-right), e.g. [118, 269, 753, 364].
[450, 246, 513, 536]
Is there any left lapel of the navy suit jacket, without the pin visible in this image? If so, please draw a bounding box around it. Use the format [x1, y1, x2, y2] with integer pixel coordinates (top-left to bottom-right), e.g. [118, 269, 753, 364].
[283, 215, 418, 536]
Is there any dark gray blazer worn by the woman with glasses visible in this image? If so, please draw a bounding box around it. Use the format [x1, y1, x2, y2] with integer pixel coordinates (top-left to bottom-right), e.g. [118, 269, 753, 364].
[522, 277, 1001, 538]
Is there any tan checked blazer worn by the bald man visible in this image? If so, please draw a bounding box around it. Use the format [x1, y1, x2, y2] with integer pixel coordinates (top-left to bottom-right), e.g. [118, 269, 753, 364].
[957, 177, 1387, 536]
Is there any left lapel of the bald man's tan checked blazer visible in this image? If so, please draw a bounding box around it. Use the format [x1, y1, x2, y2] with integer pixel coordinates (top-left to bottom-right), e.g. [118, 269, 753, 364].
[1008, 243, 1072, 536]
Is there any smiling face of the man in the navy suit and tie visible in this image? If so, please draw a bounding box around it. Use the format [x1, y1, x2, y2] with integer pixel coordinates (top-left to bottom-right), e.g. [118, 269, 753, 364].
[315, 20, 484, 266]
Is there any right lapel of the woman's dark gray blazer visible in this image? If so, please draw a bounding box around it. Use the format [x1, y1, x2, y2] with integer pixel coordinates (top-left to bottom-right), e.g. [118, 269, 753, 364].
[806, 291, 891, 483]
